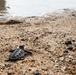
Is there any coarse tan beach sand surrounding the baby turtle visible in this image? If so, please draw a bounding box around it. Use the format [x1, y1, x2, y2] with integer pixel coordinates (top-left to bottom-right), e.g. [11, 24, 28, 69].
[0, 9, 76, 75]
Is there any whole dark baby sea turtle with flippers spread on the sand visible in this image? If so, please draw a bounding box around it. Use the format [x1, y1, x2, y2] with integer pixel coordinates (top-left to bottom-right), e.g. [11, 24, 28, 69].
[6, 45, 32, 61]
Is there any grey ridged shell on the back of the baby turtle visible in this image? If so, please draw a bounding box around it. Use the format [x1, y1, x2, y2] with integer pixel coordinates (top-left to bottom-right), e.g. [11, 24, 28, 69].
[9, 48, 25, 60]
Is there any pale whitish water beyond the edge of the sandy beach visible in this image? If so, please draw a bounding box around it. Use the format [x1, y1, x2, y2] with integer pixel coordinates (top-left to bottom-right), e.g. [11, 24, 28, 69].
[0, 0, 76, 17]
